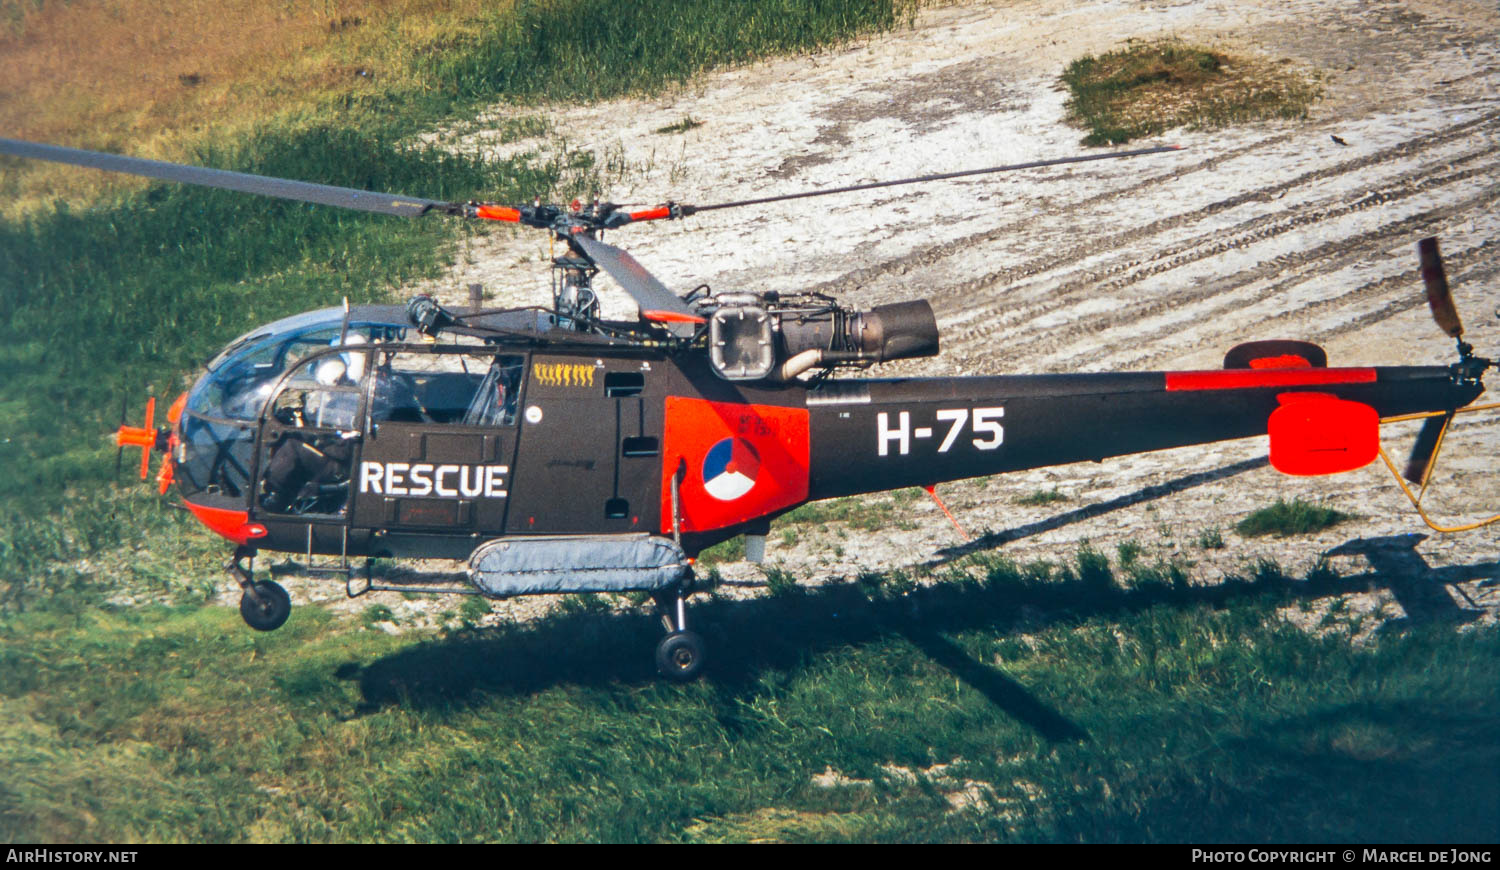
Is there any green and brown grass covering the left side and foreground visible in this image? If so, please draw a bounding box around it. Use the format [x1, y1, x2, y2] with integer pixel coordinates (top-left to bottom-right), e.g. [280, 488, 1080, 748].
[0, 0, 1500, 843]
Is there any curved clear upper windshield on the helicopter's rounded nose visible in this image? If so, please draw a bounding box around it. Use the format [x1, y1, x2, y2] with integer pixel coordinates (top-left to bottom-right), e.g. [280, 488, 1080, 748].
[188, 308, 407, 420]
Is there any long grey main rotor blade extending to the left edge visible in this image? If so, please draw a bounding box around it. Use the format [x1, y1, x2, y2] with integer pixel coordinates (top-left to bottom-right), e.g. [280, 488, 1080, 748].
[0, 138, 449, 218]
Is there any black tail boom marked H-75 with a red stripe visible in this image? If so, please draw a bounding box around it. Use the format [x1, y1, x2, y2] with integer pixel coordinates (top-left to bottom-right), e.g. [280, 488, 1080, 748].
[807, 366, 1484, 500]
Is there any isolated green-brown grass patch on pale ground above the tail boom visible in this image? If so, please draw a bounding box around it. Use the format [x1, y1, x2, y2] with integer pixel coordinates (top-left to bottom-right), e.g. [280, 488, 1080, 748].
[1062, 39, 1320, 146]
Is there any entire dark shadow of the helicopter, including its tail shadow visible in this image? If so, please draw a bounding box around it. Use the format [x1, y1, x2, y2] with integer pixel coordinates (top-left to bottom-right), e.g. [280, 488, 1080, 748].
[338, 536, 1500, 743]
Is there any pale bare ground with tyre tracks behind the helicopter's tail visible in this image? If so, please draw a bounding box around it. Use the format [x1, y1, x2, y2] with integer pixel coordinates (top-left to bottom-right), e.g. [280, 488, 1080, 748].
[405, 0, 1500, 618]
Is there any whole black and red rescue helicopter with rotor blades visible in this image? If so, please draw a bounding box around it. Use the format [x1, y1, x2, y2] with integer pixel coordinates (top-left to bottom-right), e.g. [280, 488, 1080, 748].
[0, 140, 1500, 680]
